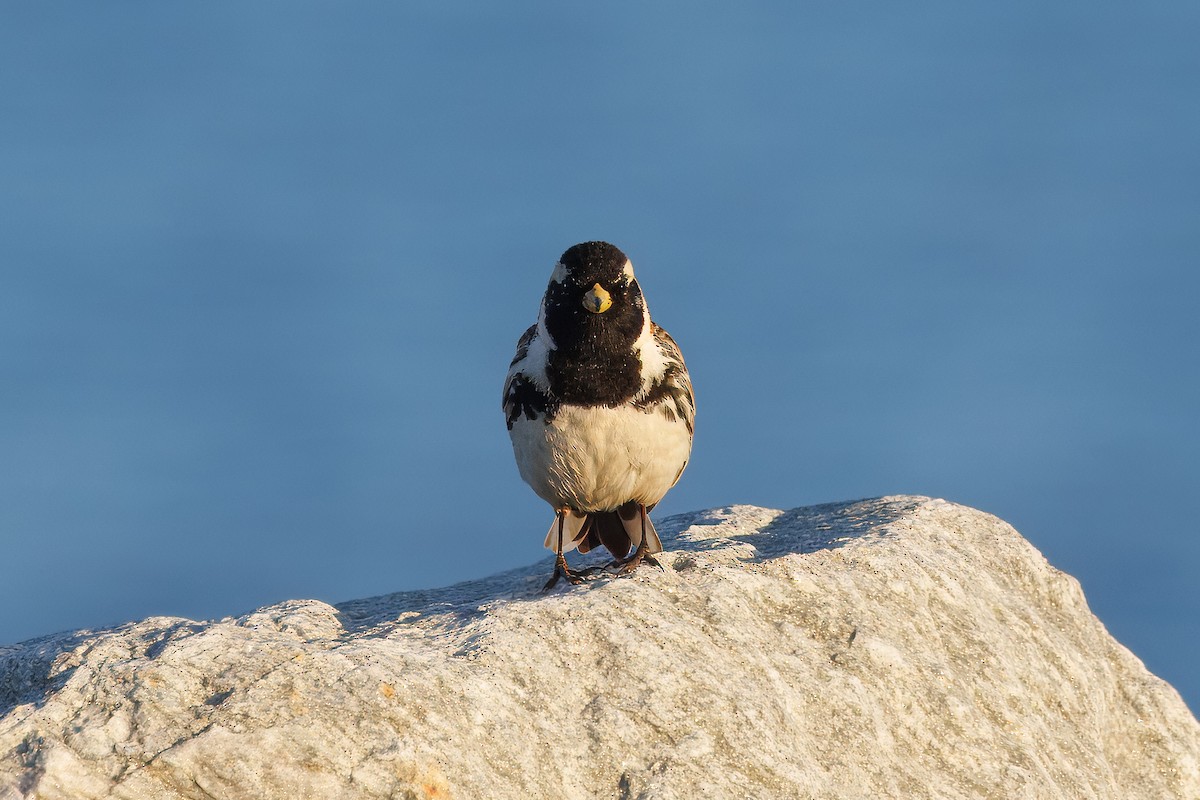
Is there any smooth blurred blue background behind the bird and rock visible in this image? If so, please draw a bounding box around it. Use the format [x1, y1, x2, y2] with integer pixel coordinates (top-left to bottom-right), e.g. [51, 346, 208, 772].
[0, 2, 1200, 709]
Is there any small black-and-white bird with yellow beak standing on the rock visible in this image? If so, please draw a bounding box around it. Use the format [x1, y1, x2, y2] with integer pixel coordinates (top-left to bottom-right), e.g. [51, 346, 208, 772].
[503, 241, 696, 591]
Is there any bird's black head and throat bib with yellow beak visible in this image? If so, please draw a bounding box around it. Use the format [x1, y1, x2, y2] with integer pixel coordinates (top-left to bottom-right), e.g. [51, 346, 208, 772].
[544, 241, 646, 403]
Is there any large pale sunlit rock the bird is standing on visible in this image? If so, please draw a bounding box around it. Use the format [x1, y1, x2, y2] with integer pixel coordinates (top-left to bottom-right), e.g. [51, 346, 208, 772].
[0, 497, 1200, 800]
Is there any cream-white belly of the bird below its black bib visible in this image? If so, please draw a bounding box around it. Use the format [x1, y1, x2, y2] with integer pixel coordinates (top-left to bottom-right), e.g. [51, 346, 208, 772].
[510, 405, 691, 511]
